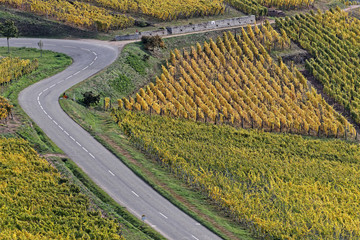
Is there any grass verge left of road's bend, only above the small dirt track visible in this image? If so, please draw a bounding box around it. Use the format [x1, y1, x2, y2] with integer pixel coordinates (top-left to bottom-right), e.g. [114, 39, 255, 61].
[0, 46, 72, 153]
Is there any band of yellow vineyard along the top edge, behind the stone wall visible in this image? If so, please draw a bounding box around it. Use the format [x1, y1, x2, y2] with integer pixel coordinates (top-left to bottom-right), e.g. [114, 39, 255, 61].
[0, 0, 314, 32]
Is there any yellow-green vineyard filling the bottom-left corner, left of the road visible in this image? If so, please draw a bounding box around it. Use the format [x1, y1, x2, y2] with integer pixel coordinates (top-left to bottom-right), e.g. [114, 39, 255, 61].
[0, 139, 122, 239]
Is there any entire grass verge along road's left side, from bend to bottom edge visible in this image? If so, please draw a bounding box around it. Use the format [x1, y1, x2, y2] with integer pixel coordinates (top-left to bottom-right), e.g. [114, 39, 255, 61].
[0, 47, 164, 240]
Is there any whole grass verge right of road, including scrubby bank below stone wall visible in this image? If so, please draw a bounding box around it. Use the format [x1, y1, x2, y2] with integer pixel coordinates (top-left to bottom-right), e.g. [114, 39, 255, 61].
[60, 35, 253, 239]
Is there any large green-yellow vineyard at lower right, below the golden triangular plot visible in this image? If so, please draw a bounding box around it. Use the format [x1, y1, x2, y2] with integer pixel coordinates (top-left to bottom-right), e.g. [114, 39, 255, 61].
[113, 110, 360, 239]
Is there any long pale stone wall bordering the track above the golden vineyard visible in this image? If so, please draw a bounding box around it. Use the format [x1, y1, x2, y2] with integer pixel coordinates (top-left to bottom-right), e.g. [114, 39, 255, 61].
[114, 15, 255, 41]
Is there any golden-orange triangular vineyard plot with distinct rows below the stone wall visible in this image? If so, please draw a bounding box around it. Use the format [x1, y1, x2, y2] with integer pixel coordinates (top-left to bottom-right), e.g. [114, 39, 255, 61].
[118, 23, 356, 138]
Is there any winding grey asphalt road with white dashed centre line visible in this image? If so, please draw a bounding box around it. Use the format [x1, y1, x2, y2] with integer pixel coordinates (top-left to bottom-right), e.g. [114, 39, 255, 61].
[0, 38, 220, 240]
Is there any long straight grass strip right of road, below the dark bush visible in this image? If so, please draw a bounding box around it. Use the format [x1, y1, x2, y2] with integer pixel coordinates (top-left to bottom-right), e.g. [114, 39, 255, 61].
[60, 97, 252, 239]
